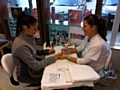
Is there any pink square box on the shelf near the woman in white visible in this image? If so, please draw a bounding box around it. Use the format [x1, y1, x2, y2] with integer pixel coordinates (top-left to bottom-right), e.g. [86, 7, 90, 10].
[68, 10, 82, 26]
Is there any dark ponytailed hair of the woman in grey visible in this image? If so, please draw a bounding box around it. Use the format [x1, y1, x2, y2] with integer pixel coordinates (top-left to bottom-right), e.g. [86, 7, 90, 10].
[16, 12, 37, 36]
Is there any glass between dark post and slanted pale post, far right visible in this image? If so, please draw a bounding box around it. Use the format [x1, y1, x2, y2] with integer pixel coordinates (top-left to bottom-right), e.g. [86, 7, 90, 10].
[101, 0, 118, 42]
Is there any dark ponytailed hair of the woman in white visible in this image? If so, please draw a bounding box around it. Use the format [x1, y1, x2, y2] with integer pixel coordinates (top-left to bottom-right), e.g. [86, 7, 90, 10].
[84, 14, 107, 41]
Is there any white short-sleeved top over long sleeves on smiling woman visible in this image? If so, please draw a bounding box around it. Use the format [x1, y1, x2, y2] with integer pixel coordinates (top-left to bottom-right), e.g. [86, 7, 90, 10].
[76, 34, 110, 70]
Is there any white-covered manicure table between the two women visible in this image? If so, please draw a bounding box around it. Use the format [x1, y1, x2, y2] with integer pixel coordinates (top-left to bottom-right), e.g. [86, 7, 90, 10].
[41, 45, 100, 90]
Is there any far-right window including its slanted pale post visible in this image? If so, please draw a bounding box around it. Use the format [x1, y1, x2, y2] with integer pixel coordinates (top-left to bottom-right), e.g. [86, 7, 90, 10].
[102, 0, 120, 46]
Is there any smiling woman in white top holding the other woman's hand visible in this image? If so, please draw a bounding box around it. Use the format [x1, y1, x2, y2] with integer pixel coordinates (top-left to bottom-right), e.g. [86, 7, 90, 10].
[61, 14, 110, 77]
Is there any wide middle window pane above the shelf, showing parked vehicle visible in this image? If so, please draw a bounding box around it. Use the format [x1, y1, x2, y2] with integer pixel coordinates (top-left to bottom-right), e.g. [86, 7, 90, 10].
[50, 0, 96, 20]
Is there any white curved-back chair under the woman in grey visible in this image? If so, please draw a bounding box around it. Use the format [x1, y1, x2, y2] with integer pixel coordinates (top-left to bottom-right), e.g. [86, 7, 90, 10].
[1, 53, 40, 90]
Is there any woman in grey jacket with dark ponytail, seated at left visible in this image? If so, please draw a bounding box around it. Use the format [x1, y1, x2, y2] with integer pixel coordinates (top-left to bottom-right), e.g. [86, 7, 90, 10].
[12, 13, 60, 85]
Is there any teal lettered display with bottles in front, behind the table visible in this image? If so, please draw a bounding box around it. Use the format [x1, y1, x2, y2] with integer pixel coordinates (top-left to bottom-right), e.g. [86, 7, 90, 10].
[48, 20, 70, 44]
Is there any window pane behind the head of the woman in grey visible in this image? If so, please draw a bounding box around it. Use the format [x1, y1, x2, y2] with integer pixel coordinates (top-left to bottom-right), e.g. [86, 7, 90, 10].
[8, 0, 40, 39]
